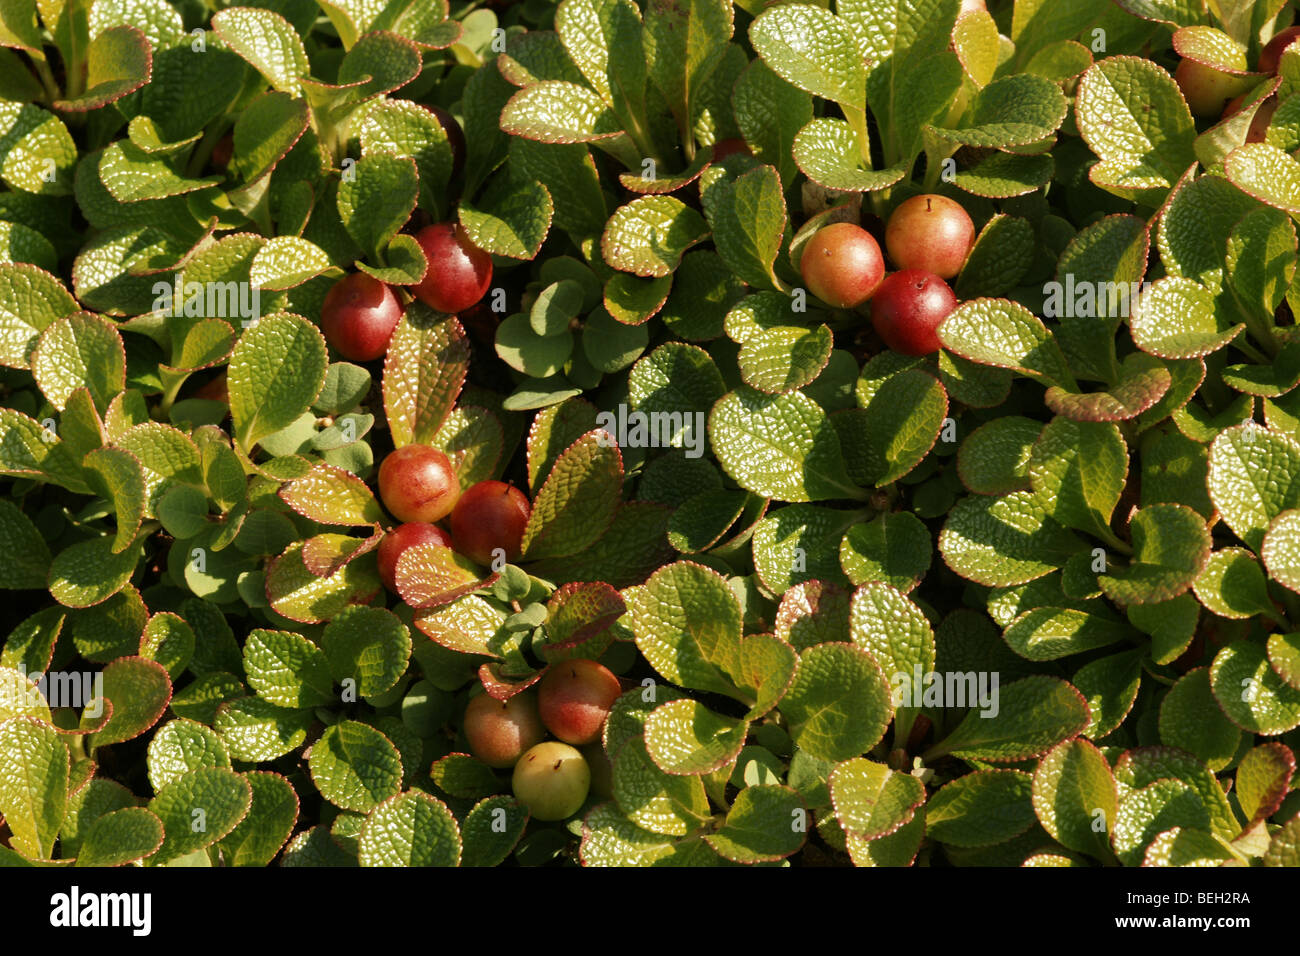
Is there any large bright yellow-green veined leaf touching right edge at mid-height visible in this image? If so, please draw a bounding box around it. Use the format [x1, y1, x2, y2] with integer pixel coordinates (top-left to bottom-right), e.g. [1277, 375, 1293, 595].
[1208, 421, 1300, 551]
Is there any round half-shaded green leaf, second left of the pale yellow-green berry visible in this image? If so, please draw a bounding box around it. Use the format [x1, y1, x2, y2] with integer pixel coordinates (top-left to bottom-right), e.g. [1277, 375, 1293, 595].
[308, 721, 402, 813]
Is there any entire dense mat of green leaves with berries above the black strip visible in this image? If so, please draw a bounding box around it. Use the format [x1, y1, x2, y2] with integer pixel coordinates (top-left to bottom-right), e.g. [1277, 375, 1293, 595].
[0, 0, 1300, 866]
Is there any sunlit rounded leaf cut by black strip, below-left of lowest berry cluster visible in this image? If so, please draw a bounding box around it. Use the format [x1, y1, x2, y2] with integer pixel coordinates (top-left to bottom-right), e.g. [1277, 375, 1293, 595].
[359, 791, 460, 866]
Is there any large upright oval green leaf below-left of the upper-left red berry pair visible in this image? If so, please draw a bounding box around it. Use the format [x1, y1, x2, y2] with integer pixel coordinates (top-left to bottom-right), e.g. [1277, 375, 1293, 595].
[229, 312, 329, 450]
